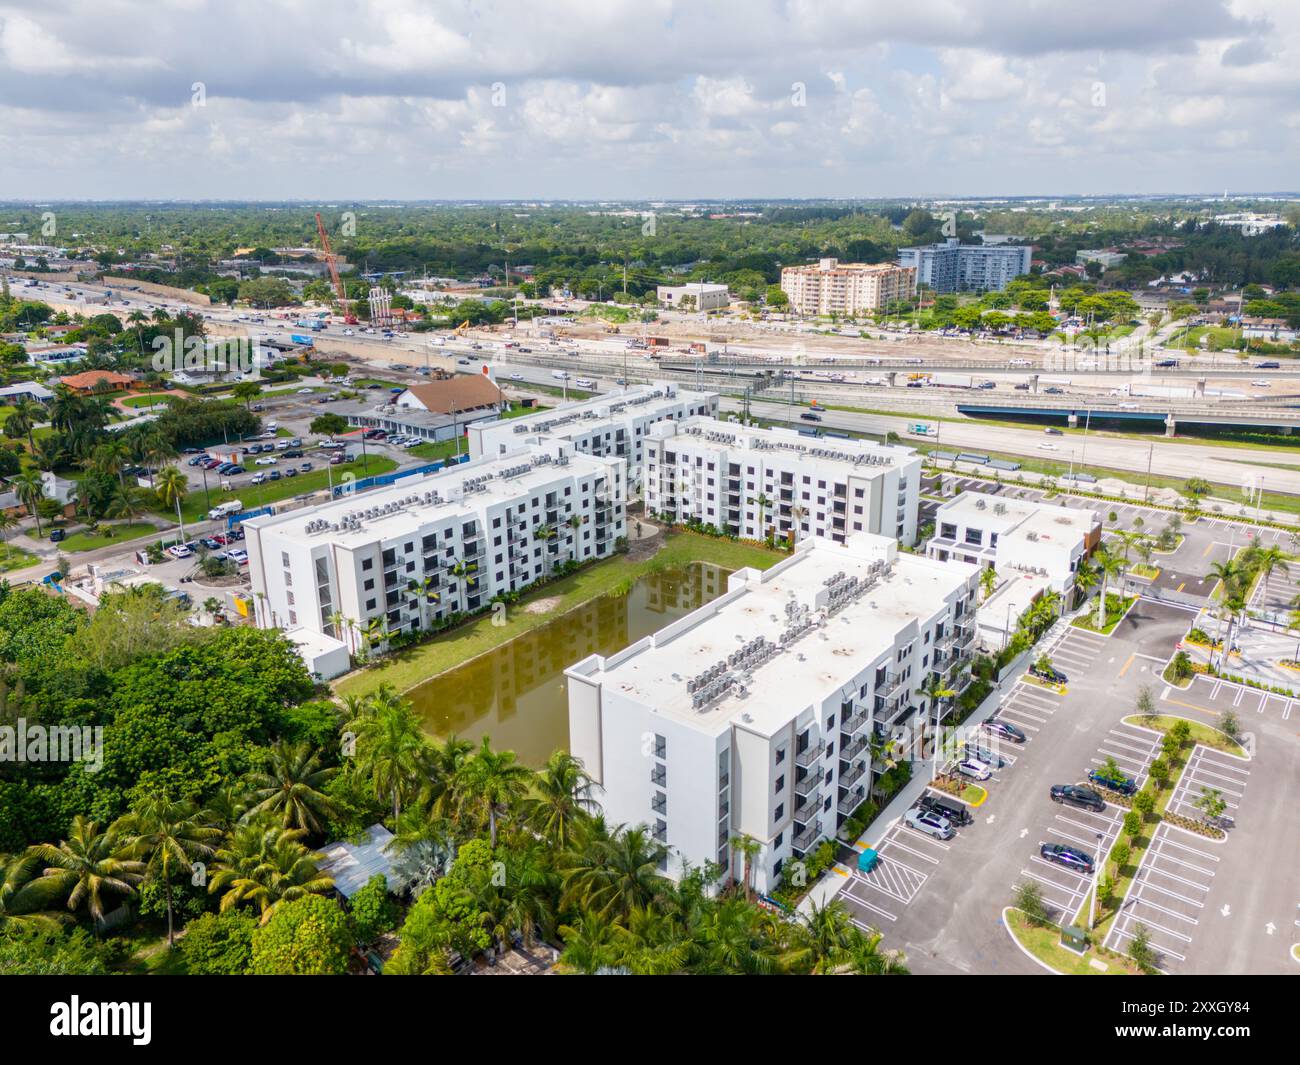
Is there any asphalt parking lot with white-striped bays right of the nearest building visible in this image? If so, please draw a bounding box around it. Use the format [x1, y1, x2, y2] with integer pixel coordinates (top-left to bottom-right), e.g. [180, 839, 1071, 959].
[836, 561, 1300, 974]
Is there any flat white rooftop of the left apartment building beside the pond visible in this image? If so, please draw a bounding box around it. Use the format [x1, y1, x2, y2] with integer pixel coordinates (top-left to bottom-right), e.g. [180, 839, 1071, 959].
[244, 446, 610, 549]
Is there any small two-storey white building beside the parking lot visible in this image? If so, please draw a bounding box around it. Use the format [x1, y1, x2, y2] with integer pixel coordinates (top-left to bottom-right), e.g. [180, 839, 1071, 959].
[926, 492, 1101, 595]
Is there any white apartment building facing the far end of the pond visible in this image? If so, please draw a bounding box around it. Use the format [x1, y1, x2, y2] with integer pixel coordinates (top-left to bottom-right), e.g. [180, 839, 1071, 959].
[644, 417, 922, 544]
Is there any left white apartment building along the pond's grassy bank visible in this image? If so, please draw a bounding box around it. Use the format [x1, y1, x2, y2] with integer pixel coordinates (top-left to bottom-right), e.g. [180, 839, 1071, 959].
[243, 443, 627, 640]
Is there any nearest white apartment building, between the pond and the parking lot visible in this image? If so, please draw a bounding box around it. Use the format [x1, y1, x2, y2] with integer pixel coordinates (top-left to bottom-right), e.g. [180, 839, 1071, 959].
[566, 534, 979, 892]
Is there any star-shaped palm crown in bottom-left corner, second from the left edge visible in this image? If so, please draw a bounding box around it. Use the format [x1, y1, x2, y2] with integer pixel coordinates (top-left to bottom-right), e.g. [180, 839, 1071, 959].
[31, 814, 147, 932]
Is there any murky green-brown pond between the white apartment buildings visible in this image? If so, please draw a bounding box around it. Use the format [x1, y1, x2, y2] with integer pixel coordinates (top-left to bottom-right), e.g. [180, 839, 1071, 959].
[407, 563, 728, 767]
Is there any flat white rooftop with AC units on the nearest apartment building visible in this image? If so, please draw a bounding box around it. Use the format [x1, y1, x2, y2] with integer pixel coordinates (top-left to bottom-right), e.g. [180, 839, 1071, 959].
[568, 533, 976, 736]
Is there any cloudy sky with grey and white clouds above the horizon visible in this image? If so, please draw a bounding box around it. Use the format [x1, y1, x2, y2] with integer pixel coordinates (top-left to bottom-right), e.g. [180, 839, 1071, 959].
[0, 0, 1300, 199]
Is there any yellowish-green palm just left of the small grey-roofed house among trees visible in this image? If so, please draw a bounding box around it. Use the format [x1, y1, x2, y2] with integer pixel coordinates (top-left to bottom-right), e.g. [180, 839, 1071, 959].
[208, 823, 334, 925]
